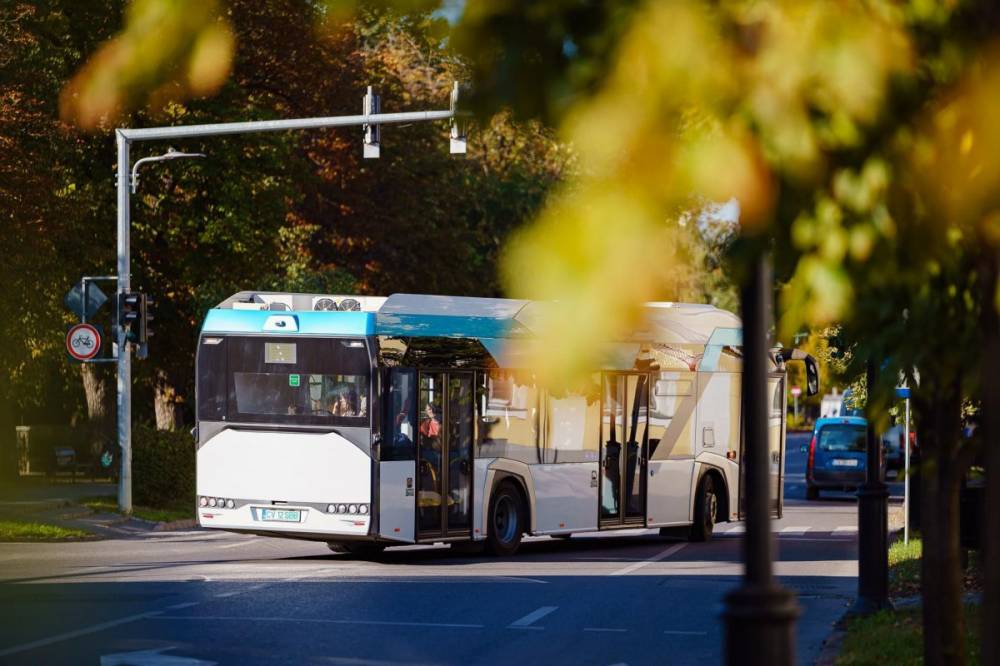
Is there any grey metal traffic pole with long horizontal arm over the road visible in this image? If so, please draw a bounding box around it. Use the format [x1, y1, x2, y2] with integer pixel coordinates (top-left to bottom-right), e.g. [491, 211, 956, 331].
[115, 83, 465, 513]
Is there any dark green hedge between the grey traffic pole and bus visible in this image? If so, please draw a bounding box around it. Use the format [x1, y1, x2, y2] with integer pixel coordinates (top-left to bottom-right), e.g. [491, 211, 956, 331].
[132, 425, 196, 509]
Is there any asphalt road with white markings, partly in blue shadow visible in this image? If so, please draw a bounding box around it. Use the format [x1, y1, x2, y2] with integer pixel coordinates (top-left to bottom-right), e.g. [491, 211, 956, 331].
[0, 435, 900, 666]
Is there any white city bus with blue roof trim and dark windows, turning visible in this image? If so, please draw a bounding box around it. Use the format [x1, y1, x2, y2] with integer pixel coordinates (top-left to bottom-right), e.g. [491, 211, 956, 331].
[194, 292, 818, 556]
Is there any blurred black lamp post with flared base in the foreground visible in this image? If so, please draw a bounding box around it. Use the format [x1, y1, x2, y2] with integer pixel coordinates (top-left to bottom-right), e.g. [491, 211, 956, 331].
[723, 250, 799, 666]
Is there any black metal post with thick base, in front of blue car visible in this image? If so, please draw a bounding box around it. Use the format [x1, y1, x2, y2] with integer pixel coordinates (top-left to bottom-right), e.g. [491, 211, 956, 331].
[851, 359, 892, 615]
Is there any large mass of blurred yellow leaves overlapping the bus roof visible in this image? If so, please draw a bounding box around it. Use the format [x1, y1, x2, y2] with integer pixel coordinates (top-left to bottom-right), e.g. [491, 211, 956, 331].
[494, 2, 913, 382]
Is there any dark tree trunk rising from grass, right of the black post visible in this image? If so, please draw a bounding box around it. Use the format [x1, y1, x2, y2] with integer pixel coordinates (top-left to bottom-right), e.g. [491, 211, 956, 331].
[920, 380, 965, 666]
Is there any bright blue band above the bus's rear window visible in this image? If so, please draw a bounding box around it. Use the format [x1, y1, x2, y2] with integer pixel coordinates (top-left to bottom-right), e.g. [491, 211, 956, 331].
[201, 309, 375, 336]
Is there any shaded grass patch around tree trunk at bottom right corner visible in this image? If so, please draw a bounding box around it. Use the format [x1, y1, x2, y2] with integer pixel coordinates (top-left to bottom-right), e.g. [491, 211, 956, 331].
[836, 606, 981, 666]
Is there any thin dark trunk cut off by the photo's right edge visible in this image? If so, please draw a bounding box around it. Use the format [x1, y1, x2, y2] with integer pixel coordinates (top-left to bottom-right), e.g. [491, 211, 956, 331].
[980, 245, 1000, 666]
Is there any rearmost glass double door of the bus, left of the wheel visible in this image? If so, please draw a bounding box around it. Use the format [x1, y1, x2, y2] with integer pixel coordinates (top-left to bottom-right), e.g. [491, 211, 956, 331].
[416, 372, 475, 539]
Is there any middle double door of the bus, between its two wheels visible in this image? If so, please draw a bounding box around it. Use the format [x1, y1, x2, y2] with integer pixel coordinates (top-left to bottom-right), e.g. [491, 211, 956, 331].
[598, 373, 649, 527]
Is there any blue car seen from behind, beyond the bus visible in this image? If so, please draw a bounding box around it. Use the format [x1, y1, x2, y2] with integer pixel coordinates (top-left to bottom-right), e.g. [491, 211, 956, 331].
[806, 416, 868, 500]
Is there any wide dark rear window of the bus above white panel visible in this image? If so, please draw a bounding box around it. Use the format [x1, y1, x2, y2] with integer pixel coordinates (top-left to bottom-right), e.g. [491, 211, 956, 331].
[198, 337, 371, 426]
